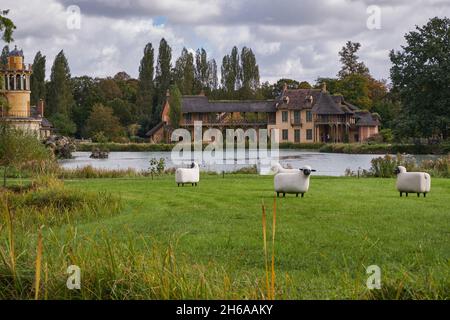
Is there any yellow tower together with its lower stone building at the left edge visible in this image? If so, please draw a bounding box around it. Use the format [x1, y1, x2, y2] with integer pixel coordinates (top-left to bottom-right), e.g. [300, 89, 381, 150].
[0, 47, 52, 138]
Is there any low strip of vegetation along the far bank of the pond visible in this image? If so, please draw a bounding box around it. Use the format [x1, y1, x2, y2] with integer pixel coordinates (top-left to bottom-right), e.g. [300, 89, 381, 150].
[76, 142, 450, 155]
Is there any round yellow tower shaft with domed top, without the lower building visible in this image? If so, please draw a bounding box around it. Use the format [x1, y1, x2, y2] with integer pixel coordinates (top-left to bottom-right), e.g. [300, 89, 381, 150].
[0, 46, 32, 118]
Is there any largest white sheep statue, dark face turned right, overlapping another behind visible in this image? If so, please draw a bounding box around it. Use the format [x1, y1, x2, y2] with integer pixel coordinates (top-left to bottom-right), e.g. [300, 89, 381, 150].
[274, 166, 316, 198]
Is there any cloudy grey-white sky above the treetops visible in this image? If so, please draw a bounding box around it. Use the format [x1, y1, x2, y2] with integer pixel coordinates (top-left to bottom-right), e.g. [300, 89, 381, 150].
[0, 0, 450, 83]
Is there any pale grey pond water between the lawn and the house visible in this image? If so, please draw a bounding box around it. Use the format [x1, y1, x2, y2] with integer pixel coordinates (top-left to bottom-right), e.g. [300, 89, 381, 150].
[60, 150, 433, 176]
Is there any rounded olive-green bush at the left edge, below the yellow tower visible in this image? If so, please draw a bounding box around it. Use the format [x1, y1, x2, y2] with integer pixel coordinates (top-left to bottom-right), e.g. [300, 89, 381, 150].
[0, 123, 51, 187]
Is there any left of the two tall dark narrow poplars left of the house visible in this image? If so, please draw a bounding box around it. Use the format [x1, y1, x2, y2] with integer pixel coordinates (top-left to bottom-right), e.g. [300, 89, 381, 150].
[136, 43, 155, 116]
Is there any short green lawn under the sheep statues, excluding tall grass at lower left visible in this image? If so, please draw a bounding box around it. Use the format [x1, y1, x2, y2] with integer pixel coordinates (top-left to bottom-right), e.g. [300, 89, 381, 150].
[0, 175, 450, 299]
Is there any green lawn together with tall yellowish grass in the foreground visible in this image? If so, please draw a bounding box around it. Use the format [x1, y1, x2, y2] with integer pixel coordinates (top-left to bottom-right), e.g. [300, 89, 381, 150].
[0, 175, 450, 299]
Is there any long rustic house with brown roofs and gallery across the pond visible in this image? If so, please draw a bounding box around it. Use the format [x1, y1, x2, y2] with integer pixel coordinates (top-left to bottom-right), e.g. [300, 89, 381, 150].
[147, 86, 380, 143]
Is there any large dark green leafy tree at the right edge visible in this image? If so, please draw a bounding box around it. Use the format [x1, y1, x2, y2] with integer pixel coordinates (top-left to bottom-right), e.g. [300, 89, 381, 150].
[390, 17, 450, 139]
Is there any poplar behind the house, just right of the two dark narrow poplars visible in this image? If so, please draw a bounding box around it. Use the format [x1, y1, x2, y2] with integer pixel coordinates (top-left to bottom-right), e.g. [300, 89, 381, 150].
[174, 48, 195, 95]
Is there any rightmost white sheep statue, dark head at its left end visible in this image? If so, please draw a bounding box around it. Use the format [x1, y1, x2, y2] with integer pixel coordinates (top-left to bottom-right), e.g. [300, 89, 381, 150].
[395, 166, 431, 197]
